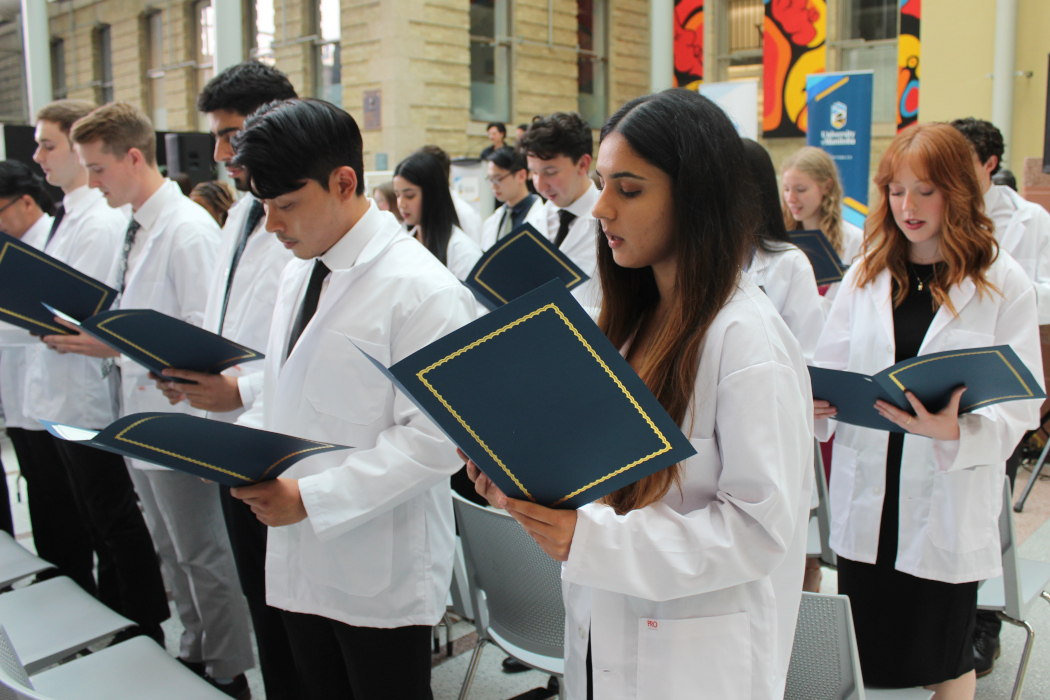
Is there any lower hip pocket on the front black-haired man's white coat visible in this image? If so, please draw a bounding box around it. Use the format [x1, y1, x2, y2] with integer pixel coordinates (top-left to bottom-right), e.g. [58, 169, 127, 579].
[299, 511, 394, 597]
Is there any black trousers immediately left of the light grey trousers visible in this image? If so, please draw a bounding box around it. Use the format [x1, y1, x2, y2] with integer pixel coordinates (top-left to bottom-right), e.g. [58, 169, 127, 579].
[53, 438, 170, 629]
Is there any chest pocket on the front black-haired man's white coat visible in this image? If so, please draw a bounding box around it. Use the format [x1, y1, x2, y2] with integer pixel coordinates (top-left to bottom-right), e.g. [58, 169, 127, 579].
[306, 330, 393, 425]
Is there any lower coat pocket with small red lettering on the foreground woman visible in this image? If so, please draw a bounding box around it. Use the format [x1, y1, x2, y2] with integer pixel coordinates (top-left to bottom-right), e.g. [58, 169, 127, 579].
[637, 613, 752, 700]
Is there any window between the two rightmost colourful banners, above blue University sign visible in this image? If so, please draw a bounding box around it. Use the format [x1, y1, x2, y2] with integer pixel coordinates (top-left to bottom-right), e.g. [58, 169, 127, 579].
[836, 0, 900, 124]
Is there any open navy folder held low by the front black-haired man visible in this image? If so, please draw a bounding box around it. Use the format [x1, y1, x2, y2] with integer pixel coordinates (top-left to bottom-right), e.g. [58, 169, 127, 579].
[41, 413, 348, 486]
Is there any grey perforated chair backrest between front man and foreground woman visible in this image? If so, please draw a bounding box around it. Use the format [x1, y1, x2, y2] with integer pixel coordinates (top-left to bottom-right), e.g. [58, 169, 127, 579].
[453, 493, 565, 659]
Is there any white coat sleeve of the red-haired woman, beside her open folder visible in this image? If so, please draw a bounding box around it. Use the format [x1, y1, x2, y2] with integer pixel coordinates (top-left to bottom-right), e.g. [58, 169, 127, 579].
[933, 287, 1043, 471]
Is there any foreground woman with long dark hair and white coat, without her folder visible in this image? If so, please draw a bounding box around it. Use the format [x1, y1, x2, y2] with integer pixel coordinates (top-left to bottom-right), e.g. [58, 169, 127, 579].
[468, 89, 813, 700]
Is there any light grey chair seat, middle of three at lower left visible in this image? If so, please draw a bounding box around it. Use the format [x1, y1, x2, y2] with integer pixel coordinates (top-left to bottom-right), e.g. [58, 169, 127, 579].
[0, 576, 134, 676]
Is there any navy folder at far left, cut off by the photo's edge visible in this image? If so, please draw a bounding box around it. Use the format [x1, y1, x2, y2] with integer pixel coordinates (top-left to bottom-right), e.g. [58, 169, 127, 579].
[0, 233, 117, 336]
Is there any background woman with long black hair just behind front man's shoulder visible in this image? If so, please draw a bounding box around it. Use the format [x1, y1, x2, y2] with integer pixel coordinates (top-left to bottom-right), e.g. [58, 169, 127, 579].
[394, 151, 481, 279]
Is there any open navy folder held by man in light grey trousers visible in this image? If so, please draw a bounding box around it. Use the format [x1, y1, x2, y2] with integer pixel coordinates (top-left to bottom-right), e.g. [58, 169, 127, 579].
[48, 306, 264, 383]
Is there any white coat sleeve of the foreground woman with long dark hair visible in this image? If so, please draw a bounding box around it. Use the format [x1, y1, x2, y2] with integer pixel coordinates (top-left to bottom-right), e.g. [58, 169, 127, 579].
[562, 361, 813, 600]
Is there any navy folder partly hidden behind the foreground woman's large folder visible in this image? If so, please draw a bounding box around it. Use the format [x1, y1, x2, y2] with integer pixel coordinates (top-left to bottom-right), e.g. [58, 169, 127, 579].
[464, 224, 590, 309]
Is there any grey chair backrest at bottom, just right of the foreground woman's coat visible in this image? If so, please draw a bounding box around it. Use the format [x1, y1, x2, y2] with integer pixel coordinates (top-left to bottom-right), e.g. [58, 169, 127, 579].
[784, 593, 864, 700]
